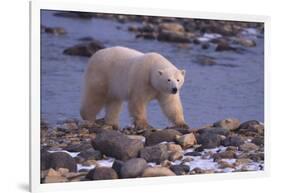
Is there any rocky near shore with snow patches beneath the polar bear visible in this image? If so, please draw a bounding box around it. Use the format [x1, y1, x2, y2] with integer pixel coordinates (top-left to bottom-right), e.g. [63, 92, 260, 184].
[41, 118, 264, 183]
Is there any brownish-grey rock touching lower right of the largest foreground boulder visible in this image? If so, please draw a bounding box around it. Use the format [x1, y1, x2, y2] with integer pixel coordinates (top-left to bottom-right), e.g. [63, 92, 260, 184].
[140, 144, 169, 164]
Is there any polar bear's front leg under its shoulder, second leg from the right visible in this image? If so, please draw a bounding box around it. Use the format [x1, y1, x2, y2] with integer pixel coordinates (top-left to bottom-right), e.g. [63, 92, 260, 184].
[128, 98, 151, 129]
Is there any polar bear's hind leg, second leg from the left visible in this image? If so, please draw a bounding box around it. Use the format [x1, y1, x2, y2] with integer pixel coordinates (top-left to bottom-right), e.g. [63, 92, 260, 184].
[105, 100, 122, 129]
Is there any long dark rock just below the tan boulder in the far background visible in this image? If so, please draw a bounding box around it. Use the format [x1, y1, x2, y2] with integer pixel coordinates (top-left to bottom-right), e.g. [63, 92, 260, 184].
[157, 31, 191, 43]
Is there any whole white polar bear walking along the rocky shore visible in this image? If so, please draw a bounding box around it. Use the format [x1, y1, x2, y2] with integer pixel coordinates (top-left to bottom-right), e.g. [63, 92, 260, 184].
[80, 47, 187, 128]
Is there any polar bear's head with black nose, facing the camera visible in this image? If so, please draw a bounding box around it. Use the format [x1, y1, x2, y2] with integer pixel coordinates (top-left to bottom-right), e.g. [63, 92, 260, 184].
[151, 68, 185, 94]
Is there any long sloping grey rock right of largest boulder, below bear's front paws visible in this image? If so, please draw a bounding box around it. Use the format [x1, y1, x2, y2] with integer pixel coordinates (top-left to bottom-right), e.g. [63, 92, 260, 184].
[145, 129, 182, 146]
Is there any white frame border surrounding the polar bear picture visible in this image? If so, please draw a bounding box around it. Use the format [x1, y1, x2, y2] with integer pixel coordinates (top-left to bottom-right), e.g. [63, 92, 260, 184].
[29, 0, 270, 192]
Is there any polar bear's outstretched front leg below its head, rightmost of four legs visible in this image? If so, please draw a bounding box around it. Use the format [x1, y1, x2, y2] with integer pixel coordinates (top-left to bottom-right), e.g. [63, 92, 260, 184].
[158, 94, 189, 128]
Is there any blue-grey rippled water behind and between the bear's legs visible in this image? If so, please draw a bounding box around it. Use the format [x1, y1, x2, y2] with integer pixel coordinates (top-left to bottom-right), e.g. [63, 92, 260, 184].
[41, 11, 264, 127]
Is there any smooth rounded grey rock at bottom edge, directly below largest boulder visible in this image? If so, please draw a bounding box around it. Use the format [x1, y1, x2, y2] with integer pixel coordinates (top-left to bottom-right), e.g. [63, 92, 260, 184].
[120, 158, 147, 178]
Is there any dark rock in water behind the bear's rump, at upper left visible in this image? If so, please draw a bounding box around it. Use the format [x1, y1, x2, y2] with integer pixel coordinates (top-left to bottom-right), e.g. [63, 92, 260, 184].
[63, 41, 105, 57]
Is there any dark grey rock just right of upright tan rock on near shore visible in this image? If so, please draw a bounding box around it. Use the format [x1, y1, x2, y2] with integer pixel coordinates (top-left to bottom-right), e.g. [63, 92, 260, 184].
[197, 132, 221, 149]
